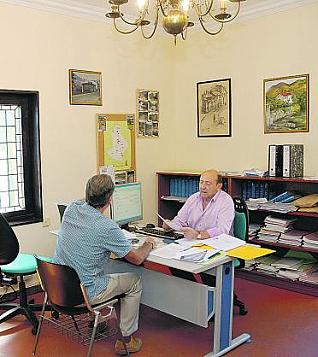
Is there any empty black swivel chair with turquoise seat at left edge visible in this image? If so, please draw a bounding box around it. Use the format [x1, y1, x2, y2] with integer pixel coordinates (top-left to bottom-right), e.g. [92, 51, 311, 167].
[0, 214, 49, 334]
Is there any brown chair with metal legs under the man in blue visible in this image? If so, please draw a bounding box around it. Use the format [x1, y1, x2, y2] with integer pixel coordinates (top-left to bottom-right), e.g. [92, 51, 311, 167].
[32, 257, 129, 357]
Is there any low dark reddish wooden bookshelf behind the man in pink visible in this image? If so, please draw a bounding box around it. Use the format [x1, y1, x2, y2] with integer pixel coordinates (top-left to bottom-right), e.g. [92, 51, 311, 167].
[157, 172, 318, 296]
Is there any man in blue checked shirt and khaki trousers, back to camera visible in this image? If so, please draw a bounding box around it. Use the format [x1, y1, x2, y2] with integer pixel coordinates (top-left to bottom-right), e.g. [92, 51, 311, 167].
[53, 174, 155, 355]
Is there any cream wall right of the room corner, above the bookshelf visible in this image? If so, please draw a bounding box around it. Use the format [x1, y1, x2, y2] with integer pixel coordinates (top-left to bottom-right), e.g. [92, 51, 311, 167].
[175, 3, 318, 176]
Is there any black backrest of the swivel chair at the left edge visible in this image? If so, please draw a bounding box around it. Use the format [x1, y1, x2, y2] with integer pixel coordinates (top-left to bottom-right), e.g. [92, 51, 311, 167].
[0, 213, 19, 265]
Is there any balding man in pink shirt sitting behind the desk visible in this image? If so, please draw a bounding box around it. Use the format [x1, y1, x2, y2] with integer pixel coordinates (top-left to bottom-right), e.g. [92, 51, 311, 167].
[162, 170, 235, 285]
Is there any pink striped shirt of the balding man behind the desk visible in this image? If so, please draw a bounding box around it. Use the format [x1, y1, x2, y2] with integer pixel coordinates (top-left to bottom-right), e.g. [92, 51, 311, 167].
[173, 190, 235, 237]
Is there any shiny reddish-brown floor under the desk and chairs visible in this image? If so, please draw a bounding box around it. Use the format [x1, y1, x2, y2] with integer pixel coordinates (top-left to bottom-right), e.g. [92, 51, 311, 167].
[0, 279, 318, 357]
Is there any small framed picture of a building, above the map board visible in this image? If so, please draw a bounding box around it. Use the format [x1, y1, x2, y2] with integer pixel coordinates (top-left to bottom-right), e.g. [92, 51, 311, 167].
[69, 69, 102, 105]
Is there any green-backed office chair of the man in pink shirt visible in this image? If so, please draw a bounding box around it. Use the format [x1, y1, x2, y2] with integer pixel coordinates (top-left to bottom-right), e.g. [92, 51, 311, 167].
[233, 197, 249, 315]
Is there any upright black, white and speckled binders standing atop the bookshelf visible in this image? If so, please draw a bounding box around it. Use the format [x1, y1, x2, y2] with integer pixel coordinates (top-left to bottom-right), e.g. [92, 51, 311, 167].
[268, 144, 304, 177]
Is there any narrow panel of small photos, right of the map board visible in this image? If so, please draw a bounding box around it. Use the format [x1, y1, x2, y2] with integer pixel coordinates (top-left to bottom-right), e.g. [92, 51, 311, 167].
[136, 89, 159, 138]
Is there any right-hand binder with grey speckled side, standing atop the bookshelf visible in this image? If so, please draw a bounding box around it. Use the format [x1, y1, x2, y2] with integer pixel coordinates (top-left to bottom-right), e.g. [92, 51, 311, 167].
[283, 144, 304, 177]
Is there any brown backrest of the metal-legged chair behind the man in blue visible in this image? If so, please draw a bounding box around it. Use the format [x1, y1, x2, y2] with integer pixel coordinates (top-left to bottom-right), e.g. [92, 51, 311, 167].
[36, 257, 84, 312]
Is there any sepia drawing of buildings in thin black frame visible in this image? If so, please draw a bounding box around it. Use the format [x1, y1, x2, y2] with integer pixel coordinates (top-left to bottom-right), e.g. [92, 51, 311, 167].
[197, 78, 231, 137]
